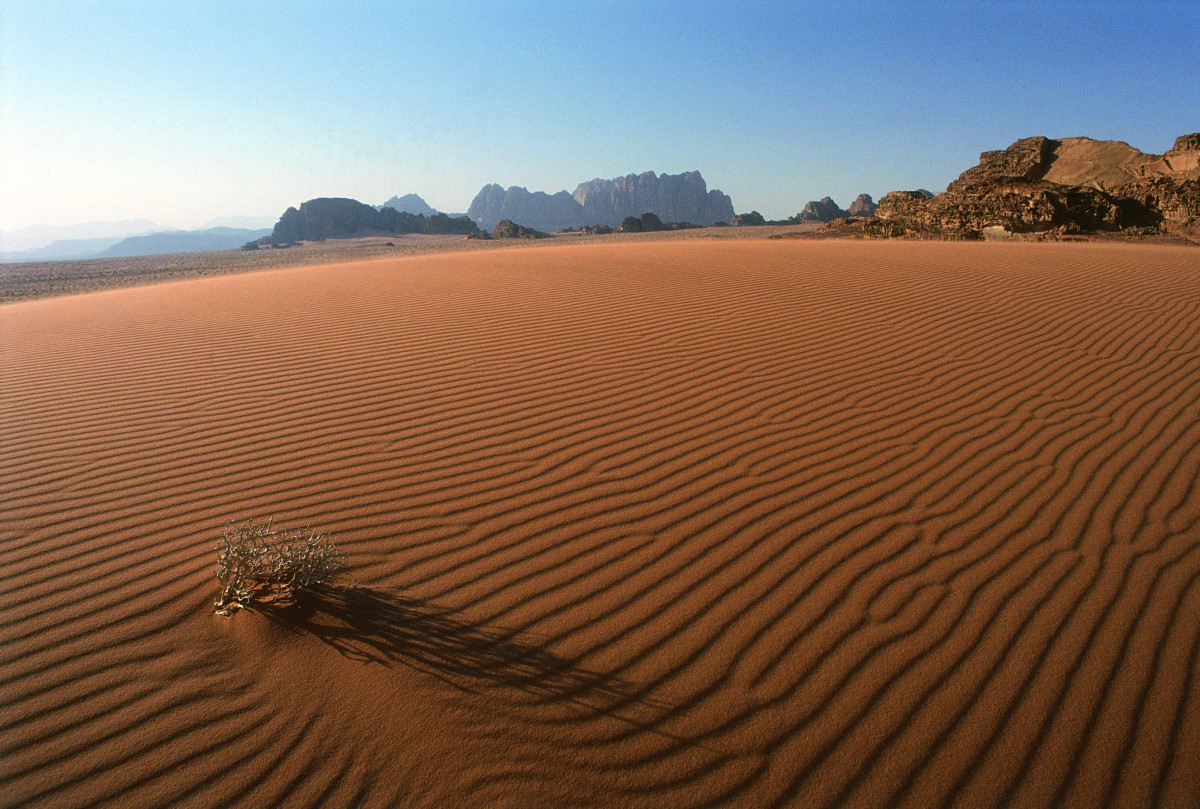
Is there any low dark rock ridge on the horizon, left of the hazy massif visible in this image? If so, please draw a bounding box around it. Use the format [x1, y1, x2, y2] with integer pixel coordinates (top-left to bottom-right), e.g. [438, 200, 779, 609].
[272, 197, 478, 244]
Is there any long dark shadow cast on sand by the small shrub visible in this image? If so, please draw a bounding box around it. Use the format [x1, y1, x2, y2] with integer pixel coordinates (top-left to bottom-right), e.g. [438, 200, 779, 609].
[253, 587, 640, 712]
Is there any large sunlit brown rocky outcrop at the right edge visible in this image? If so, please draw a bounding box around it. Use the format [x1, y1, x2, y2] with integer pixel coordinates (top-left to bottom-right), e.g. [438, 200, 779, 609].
[863, 134, 1200, 239]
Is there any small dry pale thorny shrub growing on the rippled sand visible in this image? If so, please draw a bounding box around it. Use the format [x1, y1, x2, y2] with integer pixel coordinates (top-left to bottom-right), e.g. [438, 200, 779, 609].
[216, 519, 346, 615]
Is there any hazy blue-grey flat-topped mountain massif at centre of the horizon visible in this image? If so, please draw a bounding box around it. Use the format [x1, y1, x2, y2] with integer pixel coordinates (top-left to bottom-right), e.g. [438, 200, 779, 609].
[467, 172, 733, 230]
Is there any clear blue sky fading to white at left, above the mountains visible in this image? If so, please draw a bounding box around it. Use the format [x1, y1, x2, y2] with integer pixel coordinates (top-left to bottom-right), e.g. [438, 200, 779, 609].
[0, 0, 1200, 230]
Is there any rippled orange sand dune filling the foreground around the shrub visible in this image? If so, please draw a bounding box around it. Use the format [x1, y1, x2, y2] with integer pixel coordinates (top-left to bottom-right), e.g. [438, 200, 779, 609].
[0, 241, 1200, 809]
